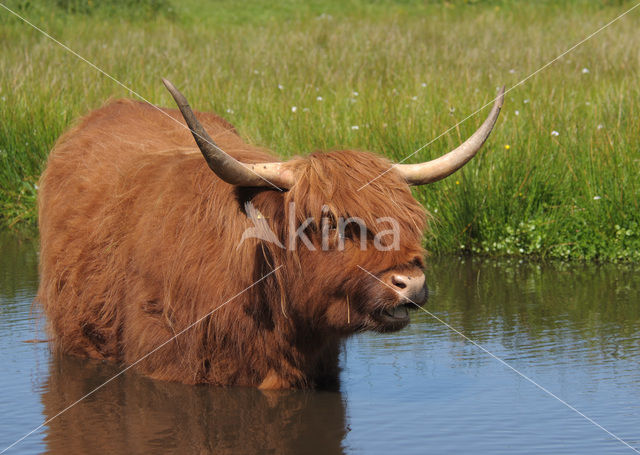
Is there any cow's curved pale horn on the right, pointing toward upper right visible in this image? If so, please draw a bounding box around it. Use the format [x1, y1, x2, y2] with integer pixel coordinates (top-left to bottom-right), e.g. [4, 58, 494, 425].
[395, 87, 504, 185]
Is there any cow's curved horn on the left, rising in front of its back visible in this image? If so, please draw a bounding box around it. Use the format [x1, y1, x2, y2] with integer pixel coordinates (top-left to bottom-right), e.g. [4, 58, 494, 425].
[162, 78, 294, 189]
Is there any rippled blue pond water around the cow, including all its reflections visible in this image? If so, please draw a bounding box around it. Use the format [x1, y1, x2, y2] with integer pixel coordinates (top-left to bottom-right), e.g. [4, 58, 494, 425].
[0, 235, 640, 454]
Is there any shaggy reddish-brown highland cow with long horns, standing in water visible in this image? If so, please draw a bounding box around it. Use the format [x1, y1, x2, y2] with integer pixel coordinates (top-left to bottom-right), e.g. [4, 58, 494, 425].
[38, 81, 503, 388]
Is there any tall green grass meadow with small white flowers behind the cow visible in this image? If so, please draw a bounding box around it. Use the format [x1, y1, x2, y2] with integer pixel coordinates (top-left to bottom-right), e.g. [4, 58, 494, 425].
[0, 0, 640, 260]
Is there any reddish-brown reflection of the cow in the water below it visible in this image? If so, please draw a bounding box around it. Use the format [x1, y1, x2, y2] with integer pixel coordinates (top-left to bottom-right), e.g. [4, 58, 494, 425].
[42, 357, 346, 454]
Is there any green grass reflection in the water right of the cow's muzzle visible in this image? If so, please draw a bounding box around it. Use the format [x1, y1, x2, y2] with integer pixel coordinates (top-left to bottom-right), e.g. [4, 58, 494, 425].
[430, 259, 640, 367]
